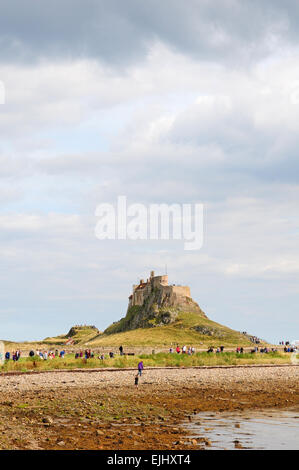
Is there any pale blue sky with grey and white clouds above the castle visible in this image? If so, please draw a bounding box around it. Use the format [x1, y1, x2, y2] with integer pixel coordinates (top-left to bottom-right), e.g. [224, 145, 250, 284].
[0, 0, 299, 341]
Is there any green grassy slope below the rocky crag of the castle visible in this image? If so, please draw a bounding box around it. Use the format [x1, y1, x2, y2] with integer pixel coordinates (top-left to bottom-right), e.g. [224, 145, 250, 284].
[89, 312, 260, 347]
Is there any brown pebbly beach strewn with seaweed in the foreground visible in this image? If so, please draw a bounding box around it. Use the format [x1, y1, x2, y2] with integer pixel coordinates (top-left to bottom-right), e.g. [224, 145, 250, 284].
[0, 366, 299, 450]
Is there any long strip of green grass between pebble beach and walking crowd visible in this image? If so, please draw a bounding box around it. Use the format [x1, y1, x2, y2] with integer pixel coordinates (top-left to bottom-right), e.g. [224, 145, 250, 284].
[0, 352, 290, 372]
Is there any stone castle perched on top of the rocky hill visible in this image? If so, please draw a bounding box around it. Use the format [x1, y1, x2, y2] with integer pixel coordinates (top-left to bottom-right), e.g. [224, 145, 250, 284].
[128, 271, 191, 308]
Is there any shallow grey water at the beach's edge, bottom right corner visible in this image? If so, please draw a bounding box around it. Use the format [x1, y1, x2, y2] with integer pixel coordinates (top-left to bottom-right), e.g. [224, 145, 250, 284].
[186, 408, 299, 450]
